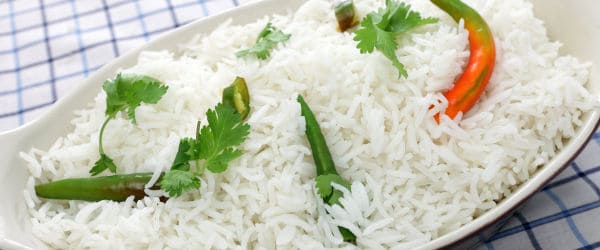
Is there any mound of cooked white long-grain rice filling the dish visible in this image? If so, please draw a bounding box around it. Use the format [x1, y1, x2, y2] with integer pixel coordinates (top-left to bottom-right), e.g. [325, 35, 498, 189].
[22, 0, 597, 249]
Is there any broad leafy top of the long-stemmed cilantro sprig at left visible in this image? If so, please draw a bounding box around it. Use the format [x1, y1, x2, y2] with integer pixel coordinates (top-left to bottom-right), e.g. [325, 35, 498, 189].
[102, 74, 168, 124]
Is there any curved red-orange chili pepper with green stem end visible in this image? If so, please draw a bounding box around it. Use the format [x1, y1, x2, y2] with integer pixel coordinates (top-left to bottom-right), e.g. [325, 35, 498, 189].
[431, 0, 496, 122]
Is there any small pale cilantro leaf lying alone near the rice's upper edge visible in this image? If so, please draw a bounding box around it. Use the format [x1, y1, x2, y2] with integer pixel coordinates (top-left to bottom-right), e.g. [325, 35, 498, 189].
[235, 23, 291, 60]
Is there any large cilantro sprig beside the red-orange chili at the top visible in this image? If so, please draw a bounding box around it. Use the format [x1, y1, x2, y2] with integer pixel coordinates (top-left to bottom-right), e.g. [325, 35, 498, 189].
[354, 0, 438, 77]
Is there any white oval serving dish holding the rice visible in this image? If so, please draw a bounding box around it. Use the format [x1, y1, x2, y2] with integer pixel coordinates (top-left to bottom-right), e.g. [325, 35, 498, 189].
[0, 0, 600, 249]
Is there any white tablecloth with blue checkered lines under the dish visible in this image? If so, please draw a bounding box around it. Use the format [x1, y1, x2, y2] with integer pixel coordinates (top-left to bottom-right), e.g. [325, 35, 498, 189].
[0, 0, 600, 249]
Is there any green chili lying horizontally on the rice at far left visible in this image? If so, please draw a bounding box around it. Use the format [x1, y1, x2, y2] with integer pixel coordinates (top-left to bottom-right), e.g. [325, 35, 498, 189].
[35, 173, 162, 201]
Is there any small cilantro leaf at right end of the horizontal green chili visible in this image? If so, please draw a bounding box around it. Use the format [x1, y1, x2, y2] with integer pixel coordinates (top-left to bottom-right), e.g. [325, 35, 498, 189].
[160, 169, 200, 197]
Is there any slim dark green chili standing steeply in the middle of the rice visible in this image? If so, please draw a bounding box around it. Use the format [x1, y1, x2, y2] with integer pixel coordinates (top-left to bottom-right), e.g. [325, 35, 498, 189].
[298, 95, 356, 243]
